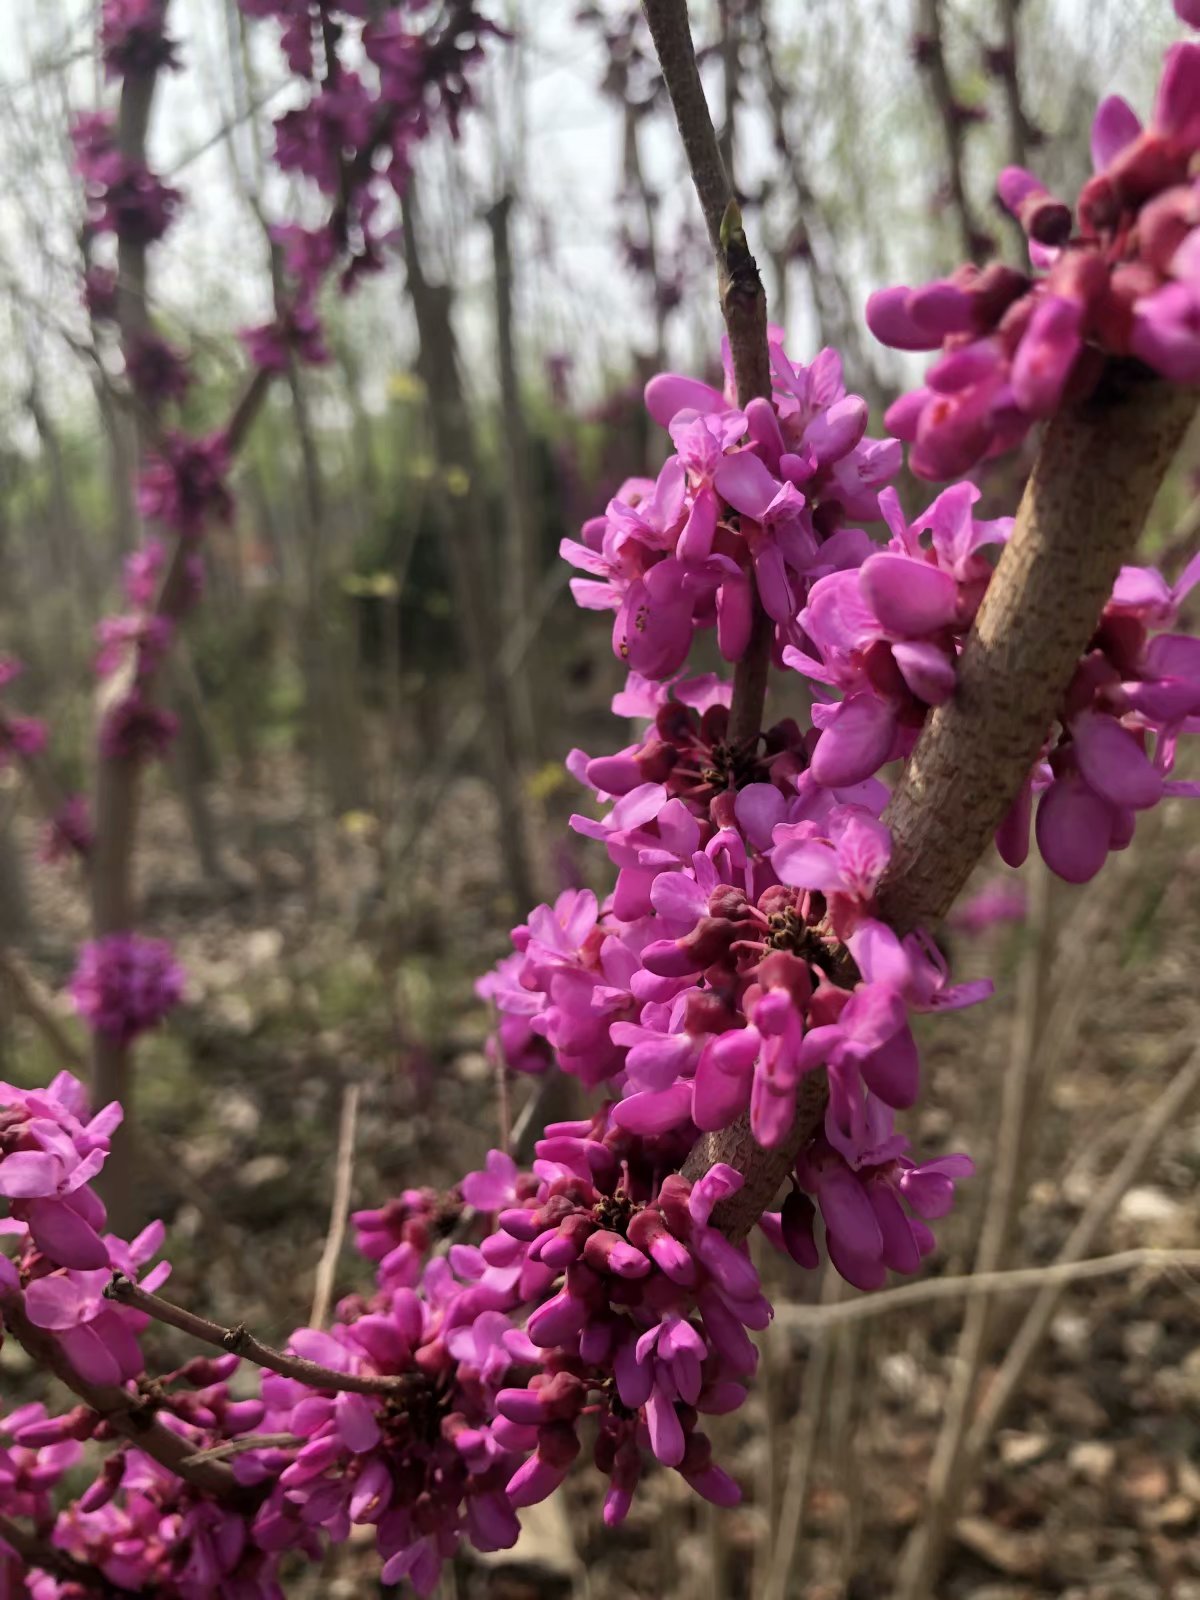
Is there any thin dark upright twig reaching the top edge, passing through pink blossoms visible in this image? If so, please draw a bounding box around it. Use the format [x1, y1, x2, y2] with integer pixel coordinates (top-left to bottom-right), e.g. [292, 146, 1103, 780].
[642, 0, 774, 744]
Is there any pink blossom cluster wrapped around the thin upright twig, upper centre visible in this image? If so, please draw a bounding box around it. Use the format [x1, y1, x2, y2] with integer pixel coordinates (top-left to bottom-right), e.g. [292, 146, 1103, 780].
[562, 330, 901, 678]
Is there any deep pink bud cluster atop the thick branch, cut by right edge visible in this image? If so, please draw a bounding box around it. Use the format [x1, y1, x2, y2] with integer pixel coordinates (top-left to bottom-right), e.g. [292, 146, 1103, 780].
[867, 43, 1200, 478]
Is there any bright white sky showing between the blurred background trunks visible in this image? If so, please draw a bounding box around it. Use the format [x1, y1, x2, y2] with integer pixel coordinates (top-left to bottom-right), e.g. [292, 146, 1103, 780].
[0, 0, 1174, 444]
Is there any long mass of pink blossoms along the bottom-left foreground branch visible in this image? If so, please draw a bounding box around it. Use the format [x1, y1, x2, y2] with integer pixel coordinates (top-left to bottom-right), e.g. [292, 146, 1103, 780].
[0, 1077, 752, 1600]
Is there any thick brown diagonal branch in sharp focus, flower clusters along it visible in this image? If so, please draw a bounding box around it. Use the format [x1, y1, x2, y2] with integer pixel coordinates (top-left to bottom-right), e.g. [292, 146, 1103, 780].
[683, 363, 1197, 1238]
